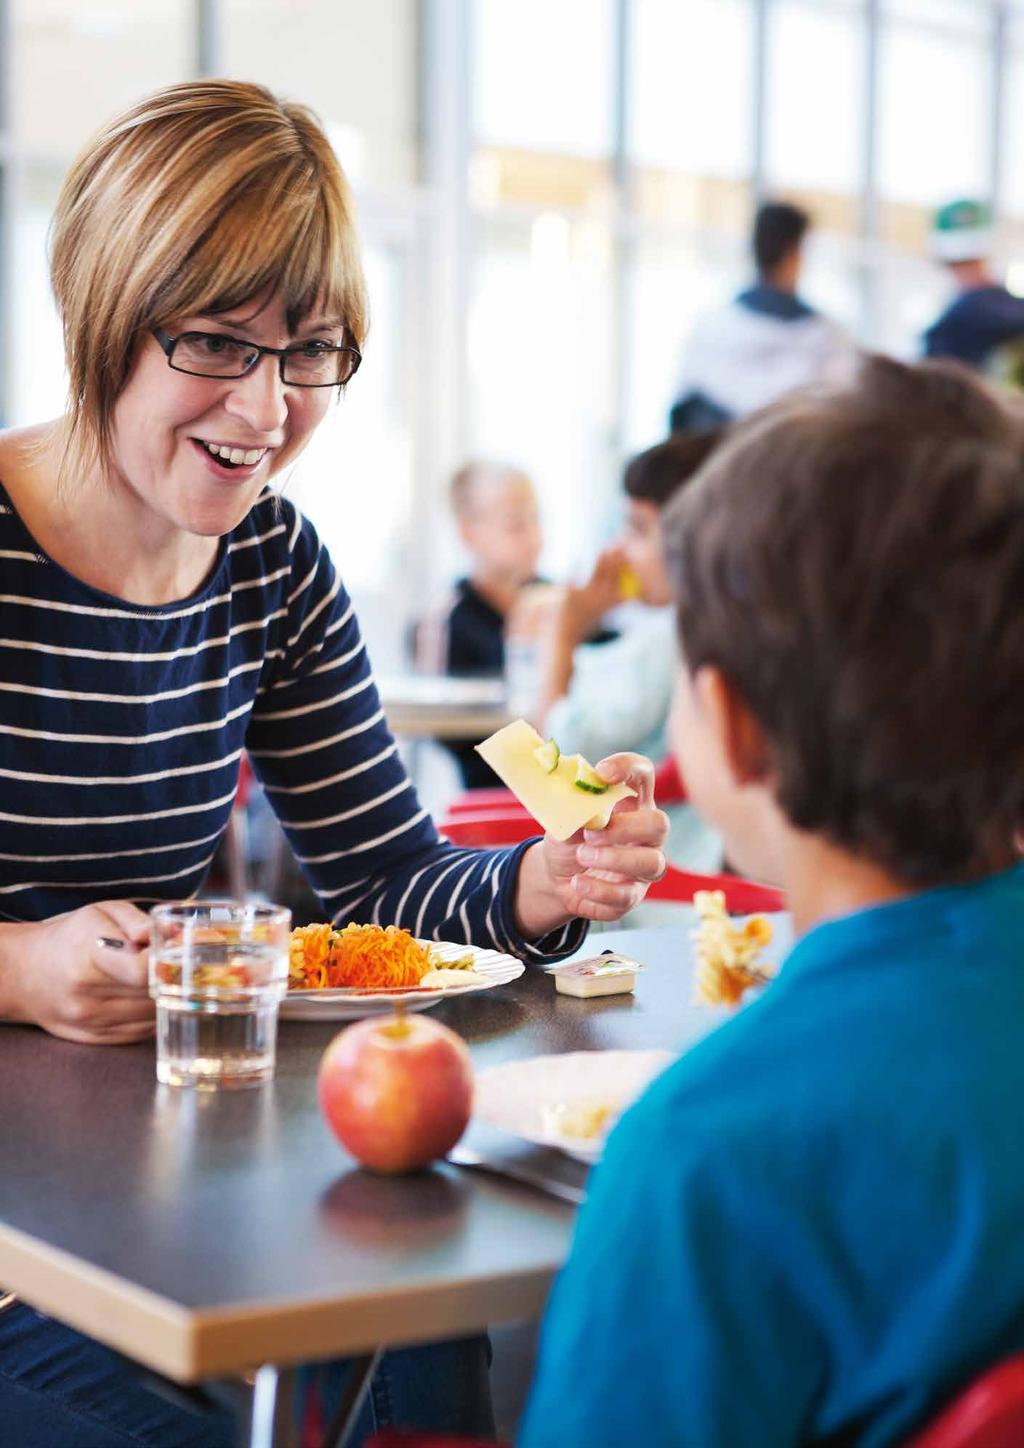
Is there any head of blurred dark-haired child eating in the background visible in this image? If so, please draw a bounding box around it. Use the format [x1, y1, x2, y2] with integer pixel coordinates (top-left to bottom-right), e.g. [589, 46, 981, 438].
[621, 430, 723, 607]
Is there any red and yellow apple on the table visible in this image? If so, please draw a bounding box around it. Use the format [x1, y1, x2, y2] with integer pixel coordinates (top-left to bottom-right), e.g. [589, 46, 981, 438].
[317, 1015, 472, 1176]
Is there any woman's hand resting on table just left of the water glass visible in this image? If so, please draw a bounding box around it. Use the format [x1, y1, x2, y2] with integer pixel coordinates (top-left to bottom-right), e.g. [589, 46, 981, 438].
[0, 901, 154, 1045]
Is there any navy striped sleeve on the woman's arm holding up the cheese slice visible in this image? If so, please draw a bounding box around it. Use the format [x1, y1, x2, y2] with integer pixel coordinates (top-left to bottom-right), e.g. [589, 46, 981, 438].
[246, 514, 585, 961]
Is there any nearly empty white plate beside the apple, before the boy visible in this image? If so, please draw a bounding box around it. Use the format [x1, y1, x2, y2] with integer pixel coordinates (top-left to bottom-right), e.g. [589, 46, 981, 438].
[474, 1051, 675, 1161]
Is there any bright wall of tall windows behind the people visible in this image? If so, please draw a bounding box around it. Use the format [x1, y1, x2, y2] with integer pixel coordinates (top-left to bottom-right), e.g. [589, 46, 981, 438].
[0, 0, 1024, 668]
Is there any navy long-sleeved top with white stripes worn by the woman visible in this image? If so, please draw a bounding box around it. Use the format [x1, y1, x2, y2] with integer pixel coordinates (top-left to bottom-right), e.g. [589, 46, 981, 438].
[0, 487, 585, 960]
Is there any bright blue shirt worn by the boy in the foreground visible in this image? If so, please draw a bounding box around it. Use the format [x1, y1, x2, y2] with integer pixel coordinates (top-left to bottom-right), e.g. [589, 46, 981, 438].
[521, 867, 1024, 1448]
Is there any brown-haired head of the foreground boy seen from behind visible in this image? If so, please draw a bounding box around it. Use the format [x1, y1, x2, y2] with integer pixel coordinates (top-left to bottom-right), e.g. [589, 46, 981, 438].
[665, 358, 1024, 888]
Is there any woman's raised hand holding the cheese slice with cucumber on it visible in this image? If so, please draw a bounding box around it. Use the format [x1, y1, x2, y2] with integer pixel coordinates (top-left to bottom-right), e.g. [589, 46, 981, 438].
[516, 754, 669, 940]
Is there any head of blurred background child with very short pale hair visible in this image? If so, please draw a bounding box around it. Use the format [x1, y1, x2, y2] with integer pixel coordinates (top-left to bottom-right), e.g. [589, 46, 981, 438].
[452, 460, 543, 586]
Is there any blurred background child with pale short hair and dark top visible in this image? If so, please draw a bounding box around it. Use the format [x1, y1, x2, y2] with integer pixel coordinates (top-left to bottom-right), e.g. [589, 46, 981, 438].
[416, 459, 543, 789]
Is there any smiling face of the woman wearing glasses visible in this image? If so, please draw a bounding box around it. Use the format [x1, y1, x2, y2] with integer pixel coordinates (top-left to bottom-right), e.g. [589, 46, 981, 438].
[109, 297, 345, 537]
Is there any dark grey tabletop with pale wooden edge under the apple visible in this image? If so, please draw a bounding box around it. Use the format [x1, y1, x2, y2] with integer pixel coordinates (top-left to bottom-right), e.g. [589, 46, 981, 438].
[0, 927, 741, 1381]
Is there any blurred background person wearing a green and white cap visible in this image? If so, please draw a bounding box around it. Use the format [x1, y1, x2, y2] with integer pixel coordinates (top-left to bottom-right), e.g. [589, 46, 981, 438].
[924, 200, 1024, 387]
